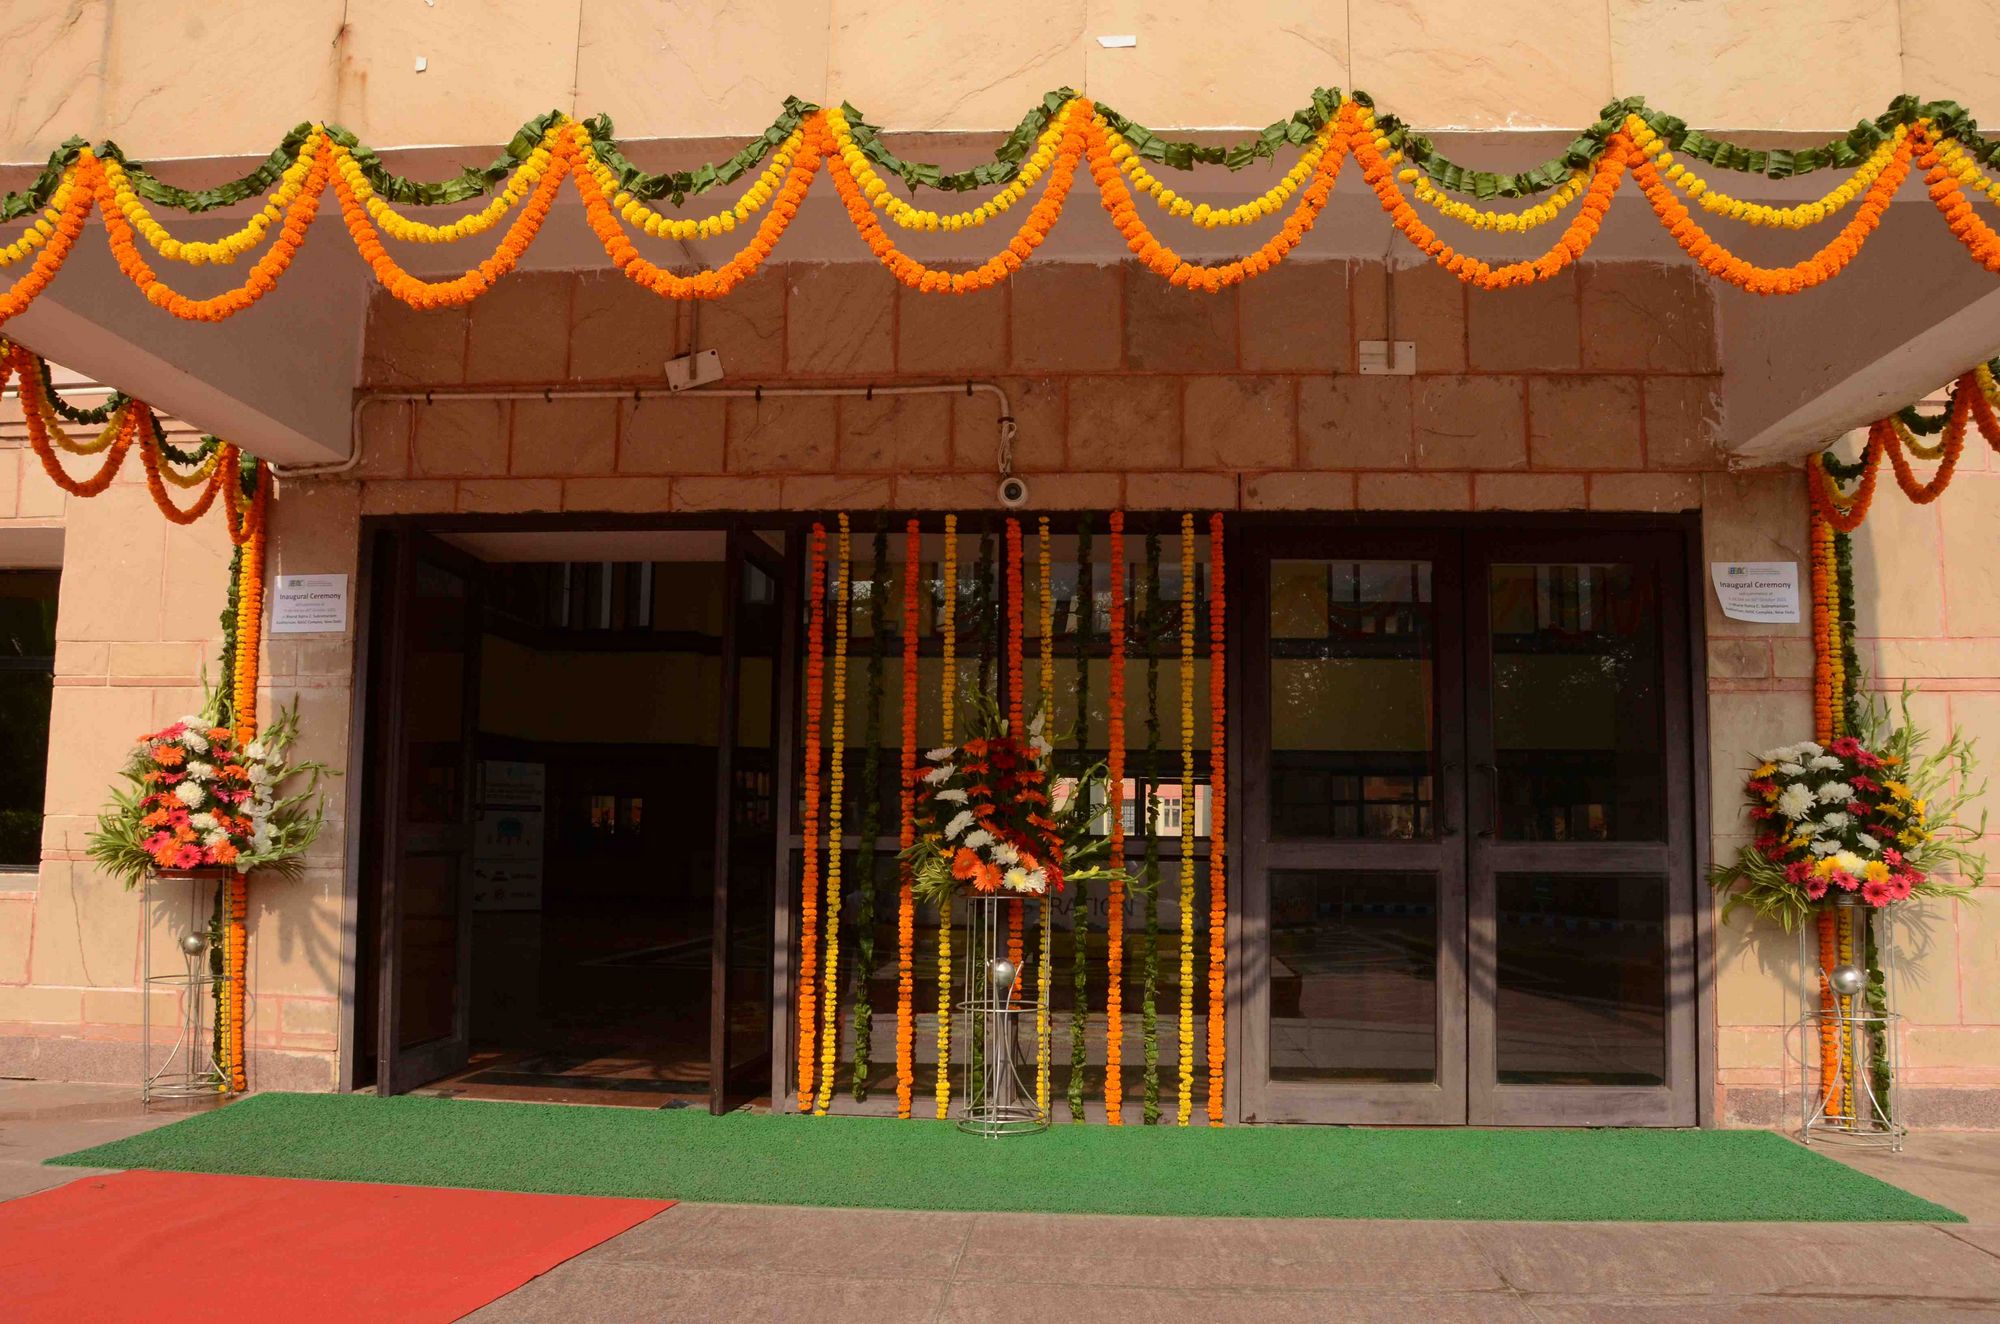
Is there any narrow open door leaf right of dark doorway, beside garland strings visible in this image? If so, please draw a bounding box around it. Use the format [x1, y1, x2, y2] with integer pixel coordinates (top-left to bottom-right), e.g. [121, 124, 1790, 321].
[708, 528, 796, 1114]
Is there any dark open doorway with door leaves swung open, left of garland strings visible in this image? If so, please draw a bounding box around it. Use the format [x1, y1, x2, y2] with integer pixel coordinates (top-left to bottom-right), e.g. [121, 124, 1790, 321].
[356, 526, 798, 1112]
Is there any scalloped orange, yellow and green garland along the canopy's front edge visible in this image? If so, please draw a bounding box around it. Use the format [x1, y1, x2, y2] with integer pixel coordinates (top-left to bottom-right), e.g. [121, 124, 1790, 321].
[0, 88, 2000, 324]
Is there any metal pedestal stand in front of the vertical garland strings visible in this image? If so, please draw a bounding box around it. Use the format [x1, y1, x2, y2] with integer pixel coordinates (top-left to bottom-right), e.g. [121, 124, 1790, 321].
[958, 894, 1048, 1136]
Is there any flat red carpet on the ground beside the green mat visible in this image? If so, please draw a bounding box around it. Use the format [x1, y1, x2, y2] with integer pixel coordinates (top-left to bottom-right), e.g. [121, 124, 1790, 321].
[0, 1172, 672, 1324]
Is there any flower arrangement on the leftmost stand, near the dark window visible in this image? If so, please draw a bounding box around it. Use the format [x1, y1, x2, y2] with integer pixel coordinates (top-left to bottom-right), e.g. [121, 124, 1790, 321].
[90, 698, 326, 886]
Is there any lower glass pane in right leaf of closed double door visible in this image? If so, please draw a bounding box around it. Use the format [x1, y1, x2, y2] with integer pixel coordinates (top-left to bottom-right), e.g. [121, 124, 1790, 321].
[1494, 874, 1666, 1086]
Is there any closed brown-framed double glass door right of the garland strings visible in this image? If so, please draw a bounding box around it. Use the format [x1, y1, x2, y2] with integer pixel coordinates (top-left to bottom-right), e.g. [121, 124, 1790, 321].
[1238, 528, 1696, 1126]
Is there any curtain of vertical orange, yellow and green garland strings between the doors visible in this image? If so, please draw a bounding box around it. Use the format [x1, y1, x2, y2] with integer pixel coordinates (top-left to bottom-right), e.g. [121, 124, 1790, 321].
[796, 512, 1228, 1126]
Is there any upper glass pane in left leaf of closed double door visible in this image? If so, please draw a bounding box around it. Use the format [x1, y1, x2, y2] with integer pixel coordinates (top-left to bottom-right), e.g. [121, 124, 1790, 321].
[1270, 560, 1436, 840]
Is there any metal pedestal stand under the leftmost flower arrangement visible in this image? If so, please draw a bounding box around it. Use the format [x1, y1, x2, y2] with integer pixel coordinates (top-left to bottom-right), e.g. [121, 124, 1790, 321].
[138, 870, 228, 1104]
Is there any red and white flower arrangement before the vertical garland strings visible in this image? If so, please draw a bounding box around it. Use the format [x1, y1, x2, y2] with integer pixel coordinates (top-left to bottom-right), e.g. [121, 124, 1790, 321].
[902, 700, 1116, 906]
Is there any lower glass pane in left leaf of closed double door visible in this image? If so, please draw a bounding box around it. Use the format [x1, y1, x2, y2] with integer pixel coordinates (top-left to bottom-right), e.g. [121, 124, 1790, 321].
[1270, 870, 1438, 1082]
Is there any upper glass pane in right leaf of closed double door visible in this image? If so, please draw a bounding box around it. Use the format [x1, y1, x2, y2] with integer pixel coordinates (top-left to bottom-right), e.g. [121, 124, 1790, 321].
[1488, 564, 1666, 842]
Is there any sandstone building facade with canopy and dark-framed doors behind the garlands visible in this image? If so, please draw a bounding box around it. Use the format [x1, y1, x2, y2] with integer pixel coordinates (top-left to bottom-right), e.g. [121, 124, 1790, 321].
[0, 0, 2000, 1126]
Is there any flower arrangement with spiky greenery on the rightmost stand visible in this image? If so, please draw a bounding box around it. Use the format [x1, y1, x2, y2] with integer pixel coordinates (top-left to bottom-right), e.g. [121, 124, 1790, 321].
[1710, 694, 1986, 932]
